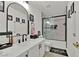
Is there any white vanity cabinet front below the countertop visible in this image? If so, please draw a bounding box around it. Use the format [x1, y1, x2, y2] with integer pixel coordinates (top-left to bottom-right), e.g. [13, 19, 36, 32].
[18, 44, 45, 57]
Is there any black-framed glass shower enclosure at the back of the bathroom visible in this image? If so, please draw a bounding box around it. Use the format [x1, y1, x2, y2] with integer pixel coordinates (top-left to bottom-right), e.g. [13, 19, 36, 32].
[42, 15, 66, 41]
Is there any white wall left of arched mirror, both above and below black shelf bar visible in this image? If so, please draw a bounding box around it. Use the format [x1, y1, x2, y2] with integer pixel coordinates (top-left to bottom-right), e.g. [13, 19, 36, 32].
[0, 2, 11, 44]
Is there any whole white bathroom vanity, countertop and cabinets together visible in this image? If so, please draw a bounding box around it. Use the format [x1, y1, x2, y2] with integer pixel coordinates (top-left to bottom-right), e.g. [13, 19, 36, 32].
[0, 38, 45, 57]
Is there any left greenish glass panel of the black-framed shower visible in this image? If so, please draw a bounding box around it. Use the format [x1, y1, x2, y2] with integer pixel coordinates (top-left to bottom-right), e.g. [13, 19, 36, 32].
[43, 19, 54, 39]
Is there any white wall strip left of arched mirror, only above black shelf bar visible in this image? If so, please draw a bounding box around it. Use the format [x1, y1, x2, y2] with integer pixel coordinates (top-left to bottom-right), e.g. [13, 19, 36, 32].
[0, 2, 11, 32]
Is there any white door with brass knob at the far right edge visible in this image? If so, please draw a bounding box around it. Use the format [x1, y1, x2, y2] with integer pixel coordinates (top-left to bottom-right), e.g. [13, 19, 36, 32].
[74, 1, 79, 57]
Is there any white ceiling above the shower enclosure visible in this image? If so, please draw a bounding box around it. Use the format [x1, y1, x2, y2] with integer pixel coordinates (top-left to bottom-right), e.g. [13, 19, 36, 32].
[29, 1, 67, 17]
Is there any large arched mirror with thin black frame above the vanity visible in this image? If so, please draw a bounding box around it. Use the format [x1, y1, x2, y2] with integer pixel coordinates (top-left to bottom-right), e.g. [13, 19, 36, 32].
[6, 3, 28, 42]
